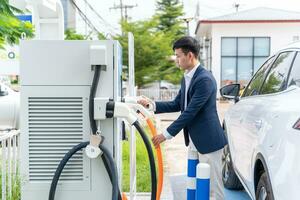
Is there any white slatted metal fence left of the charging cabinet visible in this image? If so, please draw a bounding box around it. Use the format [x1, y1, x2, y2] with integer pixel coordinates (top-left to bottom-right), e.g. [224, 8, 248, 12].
[0, 130, 20, 200]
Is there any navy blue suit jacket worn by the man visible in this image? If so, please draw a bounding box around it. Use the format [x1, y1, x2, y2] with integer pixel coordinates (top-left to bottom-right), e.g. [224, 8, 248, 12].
[155, 65, 227, 154]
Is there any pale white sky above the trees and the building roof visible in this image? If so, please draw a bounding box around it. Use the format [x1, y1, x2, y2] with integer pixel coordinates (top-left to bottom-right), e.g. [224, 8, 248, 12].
[76, 0, 300, 35]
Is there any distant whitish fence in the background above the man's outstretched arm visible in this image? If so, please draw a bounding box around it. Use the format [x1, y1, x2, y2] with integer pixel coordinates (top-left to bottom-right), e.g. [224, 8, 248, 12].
[137, 89, 179, 101]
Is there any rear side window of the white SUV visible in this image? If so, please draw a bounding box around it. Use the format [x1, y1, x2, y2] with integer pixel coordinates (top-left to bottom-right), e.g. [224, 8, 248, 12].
[260, 51, 295, 94]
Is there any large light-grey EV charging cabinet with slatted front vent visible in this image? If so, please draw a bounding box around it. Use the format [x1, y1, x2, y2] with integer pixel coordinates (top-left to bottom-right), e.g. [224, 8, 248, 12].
[20, 40, 122, 200]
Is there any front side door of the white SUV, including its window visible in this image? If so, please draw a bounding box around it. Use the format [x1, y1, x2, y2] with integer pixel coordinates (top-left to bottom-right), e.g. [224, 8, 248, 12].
[226, 56, 274, 187]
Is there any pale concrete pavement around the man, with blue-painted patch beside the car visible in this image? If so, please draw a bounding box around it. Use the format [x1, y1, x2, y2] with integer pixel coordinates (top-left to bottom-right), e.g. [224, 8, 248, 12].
[149, 102, 250, 200]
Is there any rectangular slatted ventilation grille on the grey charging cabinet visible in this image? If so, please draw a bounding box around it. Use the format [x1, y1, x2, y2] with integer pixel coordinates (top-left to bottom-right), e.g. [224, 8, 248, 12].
[28, 97, 83, 182]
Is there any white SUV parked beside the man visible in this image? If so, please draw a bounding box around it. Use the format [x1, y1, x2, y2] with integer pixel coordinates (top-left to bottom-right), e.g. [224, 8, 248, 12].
[220, 43, 300, 200]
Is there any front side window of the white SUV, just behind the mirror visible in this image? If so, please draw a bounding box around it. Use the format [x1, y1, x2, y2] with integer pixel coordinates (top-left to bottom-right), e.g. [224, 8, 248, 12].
[243, 56, 275, 97]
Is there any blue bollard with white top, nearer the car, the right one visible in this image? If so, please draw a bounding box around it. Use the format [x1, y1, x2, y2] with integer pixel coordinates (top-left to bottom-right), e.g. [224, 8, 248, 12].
[196, 163, 210, 200]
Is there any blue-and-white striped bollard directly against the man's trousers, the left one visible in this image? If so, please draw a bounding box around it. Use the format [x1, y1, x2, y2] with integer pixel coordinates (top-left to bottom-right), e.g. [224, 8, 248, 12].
[186, 148, 199, 200]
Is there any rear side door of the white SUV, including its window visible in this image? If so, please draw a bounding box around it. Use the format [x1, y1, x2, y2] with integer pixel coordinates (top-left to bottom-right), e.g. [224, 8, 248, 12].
[240, 51, 295, 187]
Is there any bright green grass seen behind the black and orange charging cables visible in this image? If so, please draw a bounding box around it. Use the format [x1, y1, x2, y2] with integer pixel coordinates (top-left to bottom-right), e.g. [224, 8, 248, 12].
[122, 130, 161, 192]
